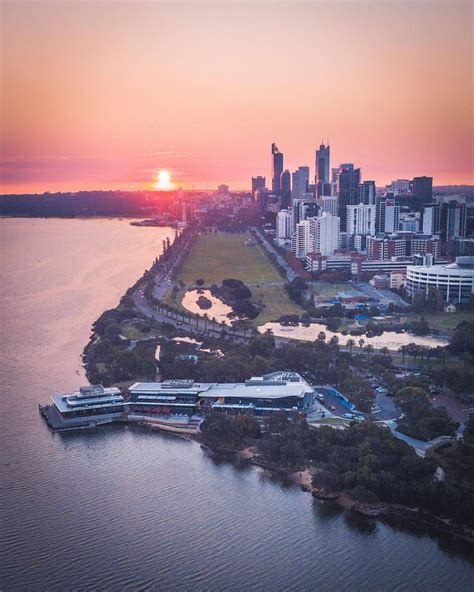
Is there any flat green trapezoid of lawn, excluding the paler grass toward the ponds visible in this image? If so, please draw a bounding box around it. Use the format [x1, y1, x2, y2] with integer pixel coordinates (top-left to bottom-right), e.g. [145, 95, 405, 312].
[176, 233, 283, 285]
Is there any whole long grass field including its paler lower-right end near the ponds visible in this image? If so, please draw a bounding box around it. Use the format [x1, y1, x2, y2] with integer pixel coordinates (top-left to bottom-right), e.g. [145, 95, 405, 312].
[172, 233, 303, 325]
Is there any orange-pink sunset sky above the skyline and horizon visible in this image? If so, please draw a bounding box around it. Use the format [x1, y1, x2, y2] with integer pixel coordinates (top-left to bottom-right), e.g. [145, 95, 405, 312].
[0, 0, 474, 193]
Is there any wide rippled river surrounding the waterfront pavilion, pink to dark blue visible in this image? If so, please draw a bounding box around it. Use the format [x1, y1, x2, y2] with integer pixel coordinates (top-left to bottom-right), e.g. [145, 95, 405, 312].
[0, 220, 474, 592]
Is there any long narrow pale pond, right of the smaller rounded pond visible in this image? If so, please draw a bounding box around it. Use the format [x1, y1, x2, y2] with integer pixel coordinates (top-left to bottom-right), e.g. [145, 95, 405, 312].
[258, 323, 448, 351]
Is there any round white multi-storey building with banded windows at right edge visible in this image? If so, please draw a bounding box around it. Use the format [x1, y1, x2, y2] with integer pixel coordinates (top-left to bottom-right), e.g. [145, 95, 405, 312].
[406, 257, 474, 304]
